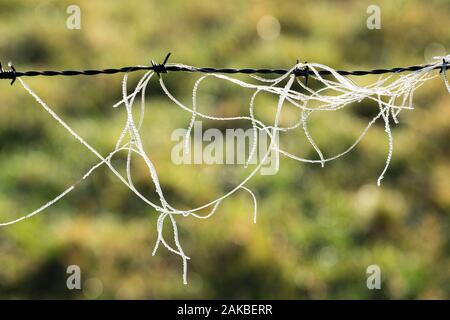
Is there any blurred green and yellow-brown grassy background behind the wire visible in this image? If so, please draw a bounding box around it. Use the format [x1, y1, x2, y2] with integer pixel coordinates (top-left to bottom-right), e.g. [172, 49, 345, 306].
[0, 0, 450, 299]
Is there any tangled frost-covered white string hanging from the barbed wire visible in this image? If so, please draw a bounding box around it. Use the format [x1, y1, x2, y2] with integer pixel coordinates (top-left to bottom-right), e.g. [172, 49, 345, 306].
[0, 56, 450, 284]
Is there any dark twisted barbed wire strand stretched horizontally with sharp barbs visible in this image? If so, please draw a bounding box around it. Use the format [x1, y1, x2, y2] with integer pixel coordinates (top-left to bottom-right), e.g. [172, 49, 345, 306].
[0, 53, 450, 84]
